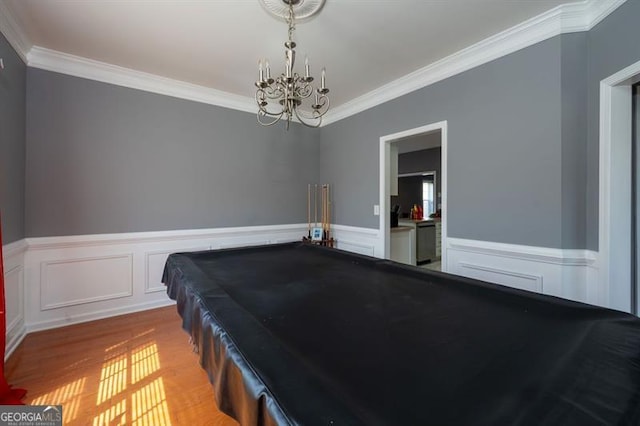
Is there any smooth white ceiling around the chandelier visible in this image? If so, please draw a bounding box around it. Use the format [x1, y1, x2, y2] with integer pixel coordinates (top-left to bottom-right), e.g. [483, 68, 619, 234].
[0, 0, 601, 111]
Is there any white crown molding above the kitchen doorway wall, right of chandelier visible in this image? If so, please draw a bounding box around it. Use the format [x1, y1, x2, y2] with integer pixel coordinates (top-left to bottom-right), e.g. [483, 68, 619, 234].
[322, 0, 626, 126]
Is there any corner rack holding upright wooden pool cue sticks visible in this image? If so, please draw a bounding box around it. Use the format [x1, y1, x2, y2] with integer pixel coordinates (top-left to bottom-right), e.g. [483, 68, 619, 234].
[302, 183, 337, 247]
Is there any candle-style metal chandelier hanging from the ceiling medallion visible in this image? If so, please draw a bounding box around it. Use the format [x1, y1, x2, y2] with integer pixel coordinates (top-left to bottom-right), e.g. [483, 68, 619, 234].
[255, 0, 329, 130]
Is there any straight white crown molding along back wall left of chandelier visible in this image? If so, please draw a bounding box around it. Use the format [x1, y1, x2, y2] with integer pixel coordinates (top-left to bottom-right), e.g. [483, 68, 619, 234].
[27, 46, 256, 112]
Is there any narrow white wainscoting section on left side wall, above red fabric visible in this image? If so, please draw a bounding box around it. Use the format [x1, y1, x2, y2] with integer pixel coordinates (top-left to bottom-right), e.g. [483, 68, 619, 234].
[2, 240, 27, 359]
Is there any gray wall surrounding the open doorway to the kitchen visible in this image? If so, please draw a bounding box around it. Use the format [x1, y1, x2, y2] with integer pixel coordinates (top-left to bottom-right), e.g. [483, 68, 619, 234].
[320, 34, 564, 247]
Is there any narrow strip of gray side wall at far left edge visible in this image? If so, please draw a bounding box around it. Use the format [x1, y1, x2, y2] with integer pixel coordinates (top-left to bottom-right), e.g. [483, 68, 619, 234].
[0, 34, 26, 244]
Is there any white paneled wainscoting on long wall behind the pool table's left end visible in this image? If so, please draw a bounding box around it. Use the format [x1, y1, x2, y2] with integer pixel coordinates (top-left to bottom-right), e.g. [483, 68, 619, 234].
[21, 224, 306, 333]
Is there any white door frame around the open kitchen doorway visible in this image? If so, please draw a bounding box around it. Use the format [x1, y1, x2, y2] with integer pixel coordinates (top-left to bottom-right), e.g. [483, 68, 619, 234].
[376, 121, 447, 271]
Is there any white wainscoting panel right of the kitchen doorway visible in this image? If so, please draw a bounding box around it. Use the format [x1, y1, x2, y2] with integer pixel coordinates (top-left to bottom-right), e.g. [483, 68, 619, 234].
[444, 237, 608, 307]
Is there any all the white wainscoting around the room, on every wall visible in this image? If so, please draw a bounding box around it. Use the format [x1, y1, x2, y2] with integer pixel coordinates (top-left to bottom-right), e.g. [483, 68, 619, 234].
[3, 224, 608, 356]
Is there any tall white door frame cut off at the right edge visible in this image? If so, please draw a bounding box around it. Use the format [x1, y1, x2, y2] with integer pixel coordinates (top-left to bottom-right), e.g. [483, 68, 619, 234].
[594, 61, 640, 312]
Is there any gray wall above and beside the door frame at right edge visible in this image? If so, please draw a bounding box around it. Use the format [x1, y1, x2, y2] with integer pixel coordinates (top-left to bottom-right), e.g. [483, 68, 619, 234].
[586, 0, 640, 250]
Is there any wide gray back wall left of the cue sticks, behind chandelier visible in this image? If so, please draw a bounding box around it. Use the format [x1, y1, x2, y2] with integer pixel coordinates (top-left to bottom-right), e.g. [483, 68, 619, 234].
[26, 68, 319, 237]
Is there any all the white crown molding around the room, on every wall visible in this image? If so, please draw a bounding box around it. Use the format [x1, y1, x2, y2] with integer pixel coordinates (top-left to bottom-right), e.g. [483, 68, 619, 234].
[0, 0, 626, 123]
